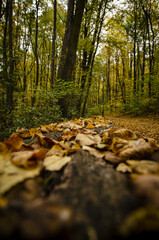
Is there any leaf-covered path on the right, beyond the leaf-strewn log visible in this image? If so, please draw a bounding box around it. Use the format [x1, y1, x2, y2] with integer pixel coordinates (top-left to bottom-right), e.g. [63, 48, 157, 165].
[105, 115, 159, 142]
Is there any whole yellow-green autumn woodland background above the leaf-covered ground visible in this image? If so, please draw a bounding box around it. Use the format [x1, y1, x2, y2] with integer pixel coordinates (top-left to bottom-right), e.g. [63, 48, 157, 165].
[0, 0, 159, 139]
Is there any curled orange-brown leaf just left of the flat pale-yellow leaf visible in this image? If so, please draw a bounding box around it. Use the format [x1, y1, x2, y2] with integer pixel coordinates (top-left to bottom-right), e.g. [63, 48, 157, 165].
[12, 148, 46, 169]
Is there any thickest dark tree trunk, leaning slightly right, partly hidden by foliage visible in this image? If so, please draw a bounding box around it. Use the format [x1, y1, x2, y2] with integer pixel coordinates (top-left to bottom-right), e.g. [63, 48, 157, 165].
[57, 0, 86, 117]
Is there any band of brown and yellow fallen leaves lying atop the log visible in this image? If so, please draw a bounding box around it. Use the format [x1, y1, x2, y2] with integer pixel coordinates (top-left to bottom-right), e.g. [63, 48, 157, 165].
[0, 116, 159, 194]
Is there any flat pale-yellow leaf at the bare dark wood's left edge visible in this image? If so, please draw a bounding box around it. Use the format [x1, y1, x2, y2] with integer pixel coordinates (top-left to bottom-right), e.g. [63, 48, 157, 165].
[43, 155, 71, 171]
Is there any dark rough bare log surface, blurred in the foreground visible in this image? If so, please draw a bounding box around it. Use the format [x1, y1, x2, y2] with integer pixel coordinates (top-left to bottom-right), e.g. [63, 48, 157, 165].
[0, 124, 159, 240]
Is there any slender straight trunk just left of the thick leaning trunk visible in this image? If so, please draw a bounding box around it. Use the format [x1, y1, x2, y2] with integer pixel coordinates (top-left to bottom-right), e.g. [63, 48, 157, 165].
[51, 0, 57, 88]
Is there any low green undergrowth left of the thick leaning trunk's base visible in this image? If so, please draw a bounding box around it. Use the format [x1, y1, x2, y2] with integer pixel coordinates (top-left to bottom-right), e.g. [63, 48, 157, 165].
[0, 90, 61, 140]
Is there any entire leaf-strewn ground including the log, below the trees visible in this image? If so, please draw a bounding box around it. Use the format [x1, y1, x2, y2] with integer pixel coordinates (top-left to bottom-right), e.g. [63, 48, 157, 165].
[0, 115, 159, 240]
